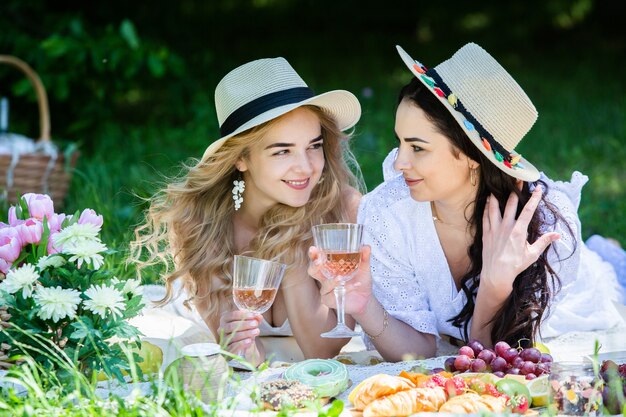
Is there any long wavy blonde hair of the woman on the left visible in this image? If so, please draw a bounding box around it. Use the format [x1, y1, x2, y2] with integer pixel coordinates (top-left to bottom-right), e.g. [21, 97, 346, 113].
[129, 106, 365, 317]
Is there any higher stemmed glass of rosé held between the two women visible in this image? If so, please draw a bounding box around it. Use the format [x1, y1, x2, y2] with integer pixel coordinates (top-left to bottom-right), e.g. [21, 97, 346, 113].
[313, 223, 363, 338]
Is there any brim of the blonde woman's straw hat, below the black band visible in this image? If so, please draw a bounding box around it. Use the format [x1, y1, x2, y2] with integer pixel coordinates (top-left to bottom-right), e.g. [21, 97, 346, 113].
[202, 90, 361, 160]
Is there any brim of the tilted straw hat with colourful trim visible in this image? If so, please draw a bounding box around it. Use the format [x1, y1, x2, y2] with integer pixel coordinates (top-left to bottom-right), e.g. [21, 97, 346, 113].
[396, 45, 539, 182]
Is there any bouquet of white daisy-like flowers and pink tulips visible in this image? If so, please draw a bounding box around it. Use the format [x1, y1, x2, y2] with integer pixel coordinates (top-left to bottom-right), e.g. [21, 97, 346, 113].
[0, 194, 143, 380]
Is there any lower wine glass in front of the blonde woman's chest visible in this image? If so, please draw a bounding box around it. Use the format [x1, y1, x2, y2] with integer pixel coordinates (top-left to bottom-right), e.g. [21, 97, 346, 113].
[233, 255, 287, 366]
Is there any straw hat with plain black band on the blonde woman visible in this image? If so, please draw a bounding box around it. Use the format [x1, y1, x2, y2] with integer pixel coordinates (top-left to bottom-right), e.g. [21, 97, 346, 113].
[202, 58, 361, 159]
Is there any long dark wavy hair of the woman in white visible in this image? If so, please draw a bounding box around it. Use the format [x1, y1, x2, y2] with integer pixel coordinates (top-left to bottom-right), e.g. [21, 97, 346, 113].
[398, 78, 575, 346]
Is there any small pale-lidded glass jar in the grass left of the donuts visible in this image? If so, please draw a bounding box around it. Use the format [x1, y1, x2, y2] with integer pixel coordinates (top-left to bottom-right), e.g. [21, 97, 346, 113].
[165, 343, 228, 403]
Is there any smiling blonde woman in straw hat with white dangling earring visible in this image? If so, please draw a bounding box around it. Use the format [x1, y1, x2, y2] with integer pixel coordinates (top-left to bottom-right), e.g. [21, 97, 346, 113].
[132, 58, 362, 364]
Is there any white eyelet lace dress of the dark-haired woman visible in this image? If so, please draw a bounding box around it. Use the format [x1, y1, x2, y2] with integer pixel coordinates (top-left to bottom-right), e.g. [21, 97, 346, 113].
[358, 146, 622, 346]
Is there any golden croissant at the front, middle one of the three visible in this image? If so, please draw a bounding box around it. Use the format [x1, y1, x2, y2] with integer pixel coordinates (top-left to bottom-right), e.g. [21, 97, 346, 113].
[363, 387, 446, 417]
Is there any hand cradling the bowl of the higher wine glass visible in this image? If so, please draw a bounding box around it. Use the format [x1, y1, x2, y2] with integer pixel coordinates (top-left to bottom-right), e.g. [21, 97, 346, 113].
[308, 245, 372, 314]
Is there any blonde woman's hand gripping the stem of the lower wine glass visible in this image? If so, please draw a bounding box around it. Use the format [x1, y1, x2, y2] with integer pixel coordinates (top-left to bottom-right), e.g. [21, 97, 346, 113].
[218, 310, 263, 360]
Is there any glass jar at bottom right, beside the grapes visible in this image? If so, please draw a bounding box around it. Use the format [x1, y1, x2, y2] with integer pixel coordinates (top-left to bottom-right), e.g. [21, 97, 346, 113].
[549, 362, 602, 417]
